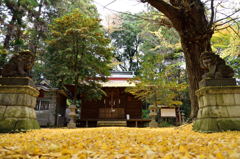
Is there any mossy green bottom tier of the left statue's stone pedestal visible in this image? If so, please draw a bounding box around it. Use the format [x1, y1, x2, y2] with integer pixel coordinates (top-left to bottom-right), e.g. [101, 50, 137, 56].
[0, 118, 40, 133]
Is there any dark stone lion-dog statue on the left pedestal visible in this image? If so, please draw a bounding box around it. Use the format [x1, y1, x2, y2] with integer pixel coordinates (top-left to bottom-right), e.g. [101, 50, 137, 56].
[2, 51, 35, 77]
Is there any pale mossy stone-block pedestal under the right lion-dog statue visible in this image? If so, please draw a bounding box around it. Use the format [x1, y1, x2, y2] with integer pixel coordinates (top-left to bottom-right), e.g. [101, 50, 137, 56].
[193, 86, 240, 132]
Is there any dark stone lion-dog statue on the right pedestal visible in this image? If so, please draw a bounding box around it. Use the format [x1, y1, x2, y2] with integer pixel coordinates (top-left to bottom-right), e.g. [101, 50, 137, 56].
[200, 51, 234, 79]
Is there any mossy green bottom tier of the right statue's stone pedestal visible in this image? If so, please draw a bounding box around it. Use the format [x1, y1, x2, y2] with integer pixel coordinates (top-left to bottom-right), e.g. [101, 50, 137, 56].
[193, 118, 240, 133]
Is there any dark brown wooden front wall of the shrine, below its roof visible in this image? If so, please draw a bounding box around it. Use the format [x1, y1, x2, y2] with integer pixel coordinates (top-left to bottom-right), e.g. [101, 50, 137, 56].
[81, 87, 142, 120]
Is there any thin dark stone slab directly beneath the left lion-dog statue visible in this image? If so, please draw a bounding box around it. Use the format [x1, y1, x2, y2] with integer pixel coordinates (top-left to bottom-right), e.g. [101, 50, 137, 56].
[0, 77, 35, 87]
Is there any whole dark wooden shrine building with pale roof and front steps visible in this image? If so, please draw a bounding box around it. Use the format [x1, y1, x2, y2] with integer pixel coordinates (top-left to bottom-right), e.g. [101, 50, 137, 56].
[77, 72, 150, 127]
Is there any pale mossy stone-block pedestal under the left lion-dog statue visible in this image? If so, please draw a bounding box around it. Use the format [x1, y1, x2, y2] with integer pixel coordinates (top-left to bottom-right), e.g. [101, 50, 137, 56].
[0, 78, 39, 132]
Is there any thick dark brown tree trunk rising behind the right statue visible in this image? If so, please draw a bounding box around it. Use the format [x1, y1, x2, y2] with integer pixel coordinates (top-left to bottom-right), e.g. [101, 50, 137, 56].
[147, 0, 213, 119]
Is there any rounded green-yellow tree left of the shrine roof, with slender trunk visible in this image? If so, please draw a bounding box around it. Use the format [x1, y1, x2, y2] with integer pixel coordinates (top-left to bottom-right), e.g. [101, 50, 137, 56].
[46, 10, 112, 103]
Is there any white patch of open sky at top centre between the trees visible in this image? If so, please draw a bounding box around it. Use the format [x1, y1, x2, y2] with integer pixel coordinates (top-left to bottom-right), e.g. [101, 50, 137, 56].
[94, 0, 144, 24]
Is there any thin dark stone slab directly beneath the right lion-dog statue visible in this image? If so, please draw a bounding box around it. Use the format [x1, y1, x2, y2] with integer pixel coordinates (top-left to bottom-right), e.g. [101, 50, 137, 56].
[199, 78, 236, 88]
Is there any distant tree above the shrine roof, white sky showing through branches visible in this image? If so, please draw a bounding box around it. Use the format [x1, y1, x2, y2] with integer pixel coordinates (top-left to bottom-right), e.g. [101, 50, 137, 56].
[110, 14, 142, 71]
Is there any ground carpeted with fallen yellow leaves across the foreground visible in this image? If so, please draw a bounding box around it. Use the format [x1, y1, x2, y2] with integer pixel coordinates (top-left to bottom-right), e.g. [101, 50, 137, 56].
[0, 125, 240, 159]
